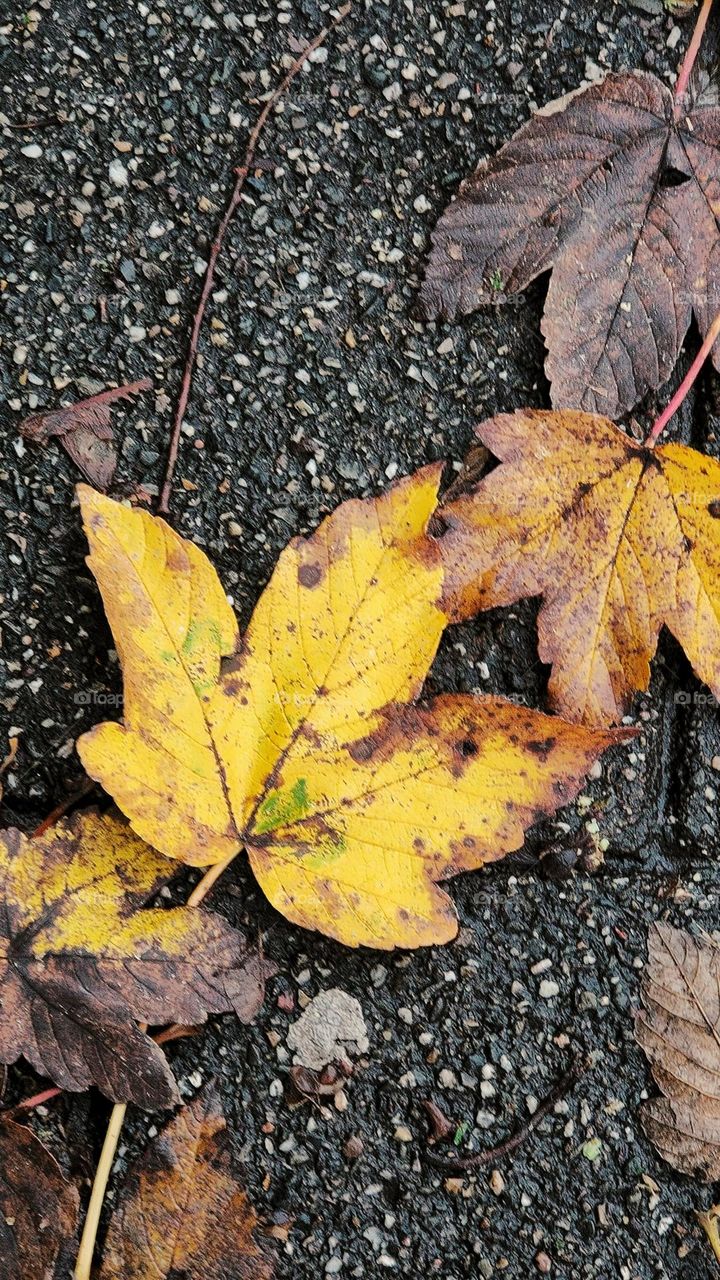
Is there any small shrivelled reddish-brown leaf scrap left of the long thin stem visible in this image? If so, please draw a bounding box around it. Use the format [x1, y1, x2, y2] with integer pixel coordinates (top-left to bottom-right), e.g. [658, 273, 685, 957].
[20, 378, 152, 490]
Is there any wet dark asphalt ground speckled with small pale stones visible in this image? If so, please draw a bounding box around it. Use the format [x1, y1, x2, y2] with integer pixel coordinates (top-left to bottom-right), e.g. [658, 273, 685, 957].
[0, 0, 720, 1280]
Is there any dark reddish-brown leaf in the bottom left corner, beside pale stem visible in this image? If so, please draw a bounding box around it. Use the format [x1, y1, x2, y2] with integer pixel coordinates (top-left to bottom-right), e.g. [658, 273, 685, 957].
[0, 1119, 78, 1280]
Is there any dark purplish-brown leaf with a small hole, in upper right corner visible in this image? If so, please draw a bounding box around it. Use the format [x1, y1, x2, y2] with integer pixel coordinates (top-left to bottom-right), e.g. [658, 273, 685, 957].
[423, 72, 720, 417]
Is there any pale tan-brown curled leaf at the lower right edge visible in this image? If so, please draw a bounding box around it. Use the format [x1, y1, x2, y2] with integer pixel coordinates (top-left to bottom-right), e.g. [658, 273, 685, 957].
[635, 924, 720, 1181]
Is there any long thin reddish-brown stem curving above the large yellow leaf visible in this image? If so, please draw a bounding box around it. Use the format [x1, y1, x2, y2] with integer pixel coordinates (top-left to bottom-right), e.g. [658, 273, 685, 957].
[158, 4, 351, 515]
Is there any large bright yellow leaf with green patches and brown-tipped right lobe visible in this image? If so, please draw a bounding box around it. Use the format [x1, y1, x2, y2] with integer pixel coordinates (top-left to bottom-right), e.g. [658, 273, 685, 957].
[78, 466, 620, 947]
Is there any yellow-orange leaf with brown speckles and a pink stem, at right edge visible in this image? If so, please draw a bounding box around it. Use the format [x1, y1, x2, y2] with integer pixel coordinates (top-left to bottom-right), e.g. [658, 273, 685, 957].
[439, 410, 720, 724]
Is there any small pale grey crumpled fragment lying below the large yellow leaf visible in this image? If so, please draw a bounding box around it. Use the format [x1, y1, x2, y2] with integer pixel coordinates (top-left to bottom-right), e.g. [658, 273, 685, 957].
[287, 987, 369, 1071]
